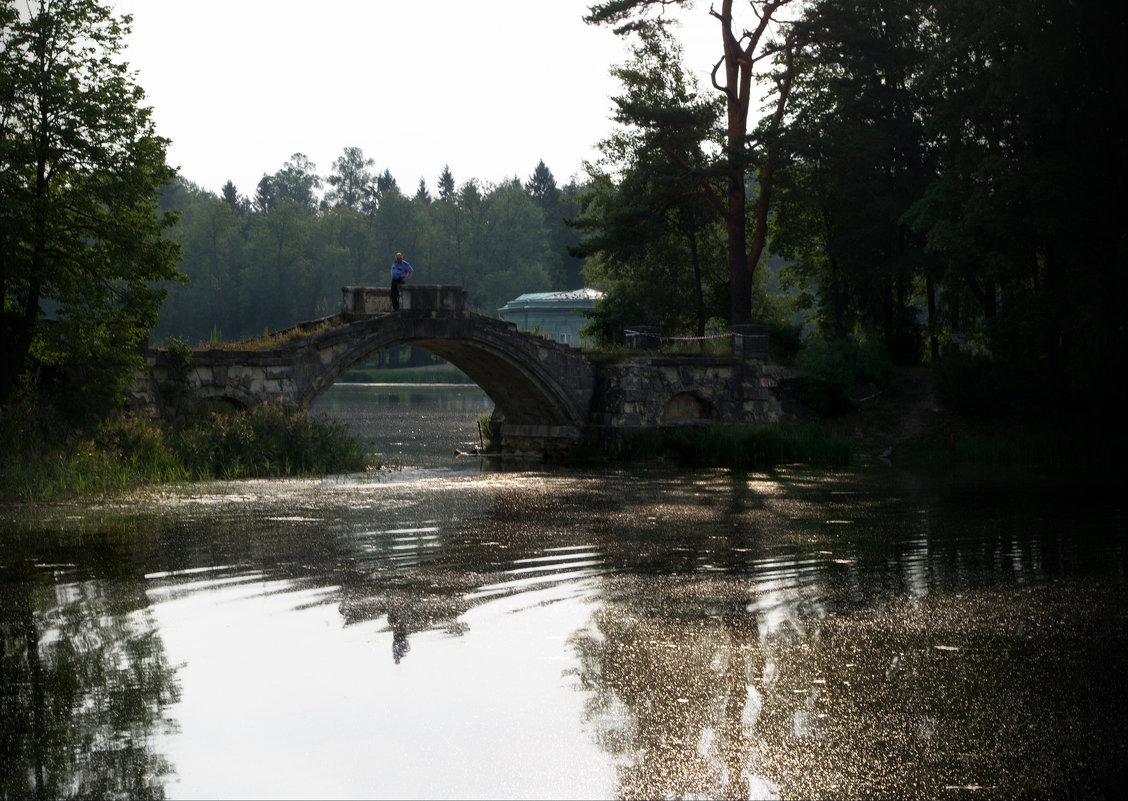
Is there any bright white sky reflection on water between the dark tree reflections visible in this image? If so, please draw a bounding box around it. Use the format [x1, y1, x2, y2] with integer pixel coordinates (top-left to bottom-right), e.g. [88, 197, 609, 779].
[147, 564, 614, 798]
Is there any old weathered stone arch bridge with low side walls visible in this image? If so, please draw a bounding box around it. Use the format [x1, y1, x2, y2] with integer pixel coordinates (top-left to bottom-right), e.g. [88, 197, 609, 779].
[127, 285, 782, 452]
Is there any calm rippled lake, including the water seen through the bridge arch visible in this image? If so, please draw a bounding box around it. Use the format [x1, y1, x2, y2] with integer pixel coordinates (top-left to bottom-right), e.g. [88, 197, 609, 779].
[0, 385, 1128, 799]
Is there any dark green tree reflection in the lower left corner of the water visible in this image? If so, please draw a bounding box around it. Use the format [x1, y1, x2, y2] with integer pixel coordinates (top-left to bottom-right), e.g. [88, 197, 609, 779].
[0, 557, 178, 799]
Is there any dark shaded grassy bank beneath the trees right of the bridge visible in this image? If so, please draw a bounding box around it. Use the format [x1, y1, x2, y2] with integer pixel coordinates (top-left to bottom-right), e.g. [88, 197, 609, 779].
[581, 368, 1126, 477]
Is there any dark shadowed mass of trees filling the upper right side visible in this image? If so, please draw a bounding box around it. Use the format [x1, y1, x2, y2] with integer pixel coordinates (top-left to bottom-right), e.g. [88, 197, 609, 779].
[773, 0, 1128, 411]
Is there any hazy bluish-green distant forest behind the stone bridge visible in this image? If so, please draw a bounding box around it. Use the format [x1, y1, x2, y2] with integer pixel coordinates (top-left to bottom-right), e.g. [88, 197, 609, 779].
[150, 156, 583, 344]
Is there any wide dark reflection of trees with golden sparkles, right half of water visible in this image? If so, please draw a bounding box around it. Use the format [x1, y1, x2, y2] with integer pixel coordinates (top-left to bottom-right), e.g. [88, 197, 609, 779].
[572, 467, 1128, 799]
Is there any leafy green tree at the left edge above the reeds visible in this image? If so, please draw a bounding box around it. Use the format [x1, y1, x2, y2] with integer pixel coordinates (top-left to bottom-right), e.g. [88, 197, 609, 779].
[0, 0, 177, 408]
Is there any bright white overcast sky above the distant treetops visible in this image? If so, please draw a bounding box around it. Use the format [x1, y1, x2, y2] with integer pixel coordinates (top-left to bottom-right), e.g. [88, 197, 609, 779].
[111, 0, 735, 195]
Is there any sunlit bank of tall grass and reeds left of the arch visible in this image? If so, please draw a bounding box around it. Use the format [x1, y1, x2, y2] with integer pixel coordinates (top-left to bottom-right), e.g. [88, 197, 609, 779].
[0, 404, 368, 502]
